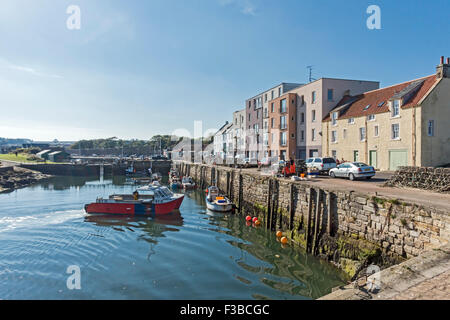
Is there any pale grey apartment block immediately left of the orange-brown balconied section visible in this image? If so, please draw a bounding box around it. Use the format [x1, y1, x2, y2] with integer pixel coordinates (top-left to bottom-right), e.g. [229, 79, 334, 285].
[245, 83, 301, 159]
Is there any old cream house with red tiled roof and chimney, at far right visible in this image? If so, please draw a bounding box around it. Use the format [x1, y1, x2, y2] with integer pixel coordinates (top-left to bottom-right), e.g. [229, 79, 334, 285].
[322, 57, 450, 170]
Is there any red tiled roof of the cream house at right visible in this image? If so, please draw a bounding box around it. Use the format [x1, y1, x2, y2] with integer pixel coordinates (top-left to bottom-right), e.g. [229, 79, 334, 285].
[323, 75, 437, 121]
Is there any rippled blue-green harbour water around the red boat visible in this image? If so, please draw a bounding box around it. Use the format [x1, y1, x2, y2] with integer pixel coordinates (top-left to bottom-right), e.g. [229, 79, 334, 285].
[0, 177, 347, 300]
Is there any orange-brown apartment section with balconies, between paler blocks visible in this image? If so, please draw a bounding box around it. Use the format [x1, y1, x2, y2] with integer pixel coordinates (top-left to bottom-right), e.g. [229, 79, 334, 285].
[267, 93, 297, 160]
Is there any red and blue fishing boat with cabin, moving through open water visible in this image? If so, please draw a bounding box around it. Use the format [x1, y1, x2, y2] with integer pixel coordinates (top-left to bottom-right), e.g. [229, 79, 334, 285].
[84, 184, 184, 216]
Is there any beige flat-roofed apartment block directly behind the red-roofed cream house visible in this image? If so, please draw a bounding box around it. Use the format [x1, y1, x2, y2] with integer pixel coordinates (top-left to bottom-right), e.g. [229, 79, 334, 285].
[289, 78, 380, 159]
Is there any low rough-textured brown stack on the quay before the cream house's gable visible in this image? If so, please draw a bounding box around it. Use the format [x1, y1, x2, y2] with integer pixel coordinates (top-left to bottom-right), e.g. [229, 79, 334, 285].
[386, 167, 450, 192]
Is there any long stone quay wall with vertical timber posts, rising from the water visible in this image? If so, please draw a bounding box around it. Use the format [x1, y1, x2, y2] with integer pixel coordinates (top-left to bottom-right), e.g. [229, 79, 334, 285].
[178, 163, 450, 276]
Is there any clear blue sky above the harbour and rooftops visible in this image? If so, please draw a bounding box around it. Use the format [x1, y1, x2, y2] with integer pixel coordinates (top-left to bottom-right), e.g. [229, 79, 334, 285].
[0, 0, 450, 140]
